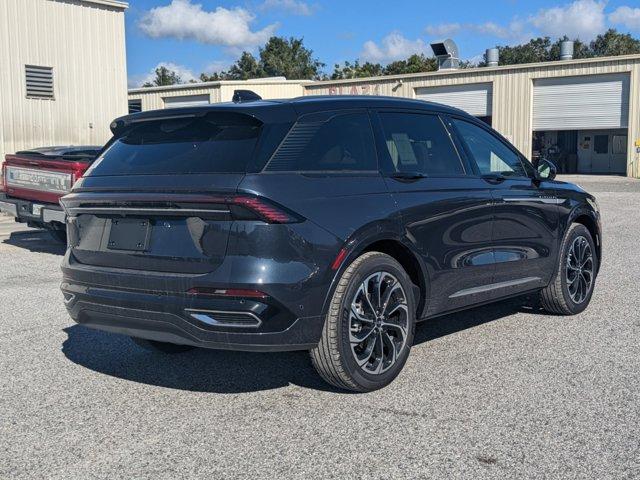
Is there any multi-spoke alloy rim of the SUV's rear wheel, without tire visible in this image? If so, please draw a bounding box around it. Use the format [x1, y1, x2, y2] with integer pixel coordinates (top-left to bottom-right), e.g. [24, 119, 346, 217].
[349, 272, 409, 375]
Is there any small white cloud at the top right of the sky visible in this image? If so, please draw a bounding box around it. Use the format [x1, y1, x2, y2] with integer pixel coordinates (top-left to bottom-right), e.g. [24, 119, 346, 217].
[529, 0, 606, 41]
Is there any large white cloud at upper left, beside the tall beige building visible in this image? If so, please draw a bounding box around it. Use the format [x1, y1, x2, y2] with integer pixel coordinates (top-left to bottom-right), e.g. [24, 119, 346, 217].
[139, 0, 278, 48]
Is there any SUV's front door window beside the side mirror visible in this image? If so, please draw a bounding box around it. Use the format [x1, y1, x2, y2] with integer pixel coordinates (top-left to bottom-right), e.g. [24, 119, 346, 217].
[451, 118, 527, 177]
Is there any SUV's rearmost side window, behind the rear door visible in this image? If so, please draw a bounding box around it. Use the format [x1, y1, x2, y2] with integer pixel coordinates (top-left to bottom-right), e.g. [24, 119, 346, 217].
[266, 112, 378, 172]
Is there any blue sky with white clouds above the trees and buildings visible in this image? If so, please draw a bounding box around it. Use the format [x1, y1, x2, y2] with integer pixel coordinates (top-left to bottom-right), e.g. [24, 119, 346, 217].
[126, 0, 640, 86]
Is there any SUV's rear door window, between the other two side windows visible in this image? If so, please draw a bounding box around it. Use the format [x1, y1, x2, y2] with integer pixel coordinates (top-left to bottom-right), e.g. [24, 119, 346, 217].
[380, 112, 464, 176]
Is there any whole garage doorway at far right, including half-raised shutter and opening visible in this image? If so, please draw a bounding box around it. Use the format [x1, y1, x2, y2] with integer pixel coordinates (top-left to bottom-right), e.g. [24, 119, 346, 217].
[533, 73, 630, 174]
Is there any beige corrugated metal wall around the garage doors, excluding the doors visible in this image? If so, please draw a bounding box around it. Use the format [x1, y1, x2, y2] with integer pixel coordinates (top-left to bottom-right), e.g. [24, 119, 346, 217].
[305, 55, 640, 177]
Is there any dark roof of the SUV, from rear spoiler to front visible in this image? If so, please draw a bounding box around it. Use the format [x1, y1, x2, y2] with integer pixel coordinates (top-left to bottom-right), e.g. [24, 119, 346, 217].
[111, 95, 467, 132]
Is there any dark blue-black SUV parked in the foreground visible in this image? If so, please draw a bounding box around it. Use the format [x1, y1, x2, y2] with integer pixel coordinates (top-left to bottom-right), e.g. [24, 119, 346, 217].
[62, 96, 601, 391]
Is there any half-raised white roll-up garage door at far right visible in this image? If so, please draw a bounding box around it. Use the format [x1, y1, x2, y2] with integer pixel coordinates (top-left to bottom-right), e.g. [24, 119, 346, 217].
[533, 74, 629, 130]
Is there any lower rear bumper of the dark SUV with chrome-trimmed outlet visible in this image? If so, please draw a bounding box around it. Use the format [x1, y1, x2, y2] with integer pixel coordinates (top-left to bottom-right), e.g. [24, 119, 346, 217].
[61, 279, 323, 351]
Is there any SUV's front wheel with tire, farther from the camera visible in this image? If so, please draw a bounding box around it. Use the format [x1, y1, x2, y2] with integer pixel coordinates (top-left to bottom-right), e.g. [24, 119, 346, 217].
[540, 223, 599, 315]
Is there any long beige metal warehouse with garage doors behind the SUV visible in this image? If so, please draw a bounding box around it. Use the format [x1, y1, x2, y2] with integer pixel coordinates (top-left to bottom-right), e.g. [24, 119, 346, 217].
[129, 55, 640, 177]
